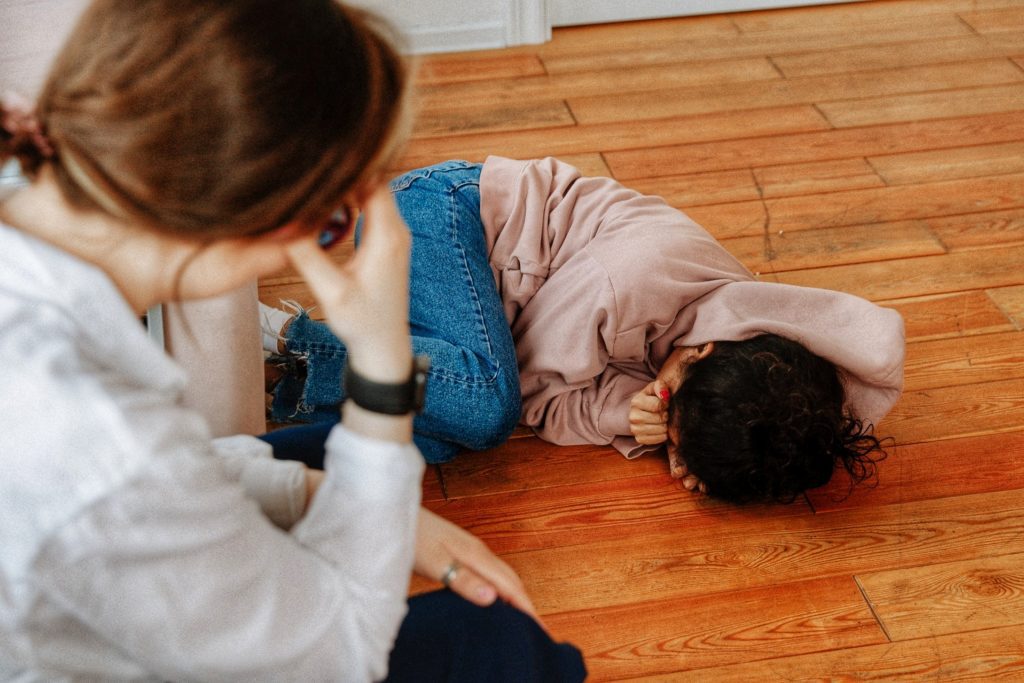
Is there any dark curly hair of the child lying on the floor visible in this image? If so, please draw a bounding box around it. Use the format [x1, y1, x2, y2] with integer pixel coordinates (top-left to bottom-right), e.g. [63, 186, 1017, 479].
[669, 334, 886, 504]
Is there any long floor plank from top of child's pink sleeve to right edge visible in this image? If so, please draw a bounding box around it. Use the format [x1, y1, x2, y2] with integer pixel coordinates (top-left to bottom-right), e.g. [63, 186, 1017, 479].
[777, 245, 1024, 301]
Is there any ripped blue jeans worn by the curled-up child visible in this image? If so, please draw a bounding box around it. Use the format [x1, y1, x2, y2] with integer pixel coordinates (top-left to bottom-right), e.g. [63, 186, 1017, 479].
[271, 161, 522, 463]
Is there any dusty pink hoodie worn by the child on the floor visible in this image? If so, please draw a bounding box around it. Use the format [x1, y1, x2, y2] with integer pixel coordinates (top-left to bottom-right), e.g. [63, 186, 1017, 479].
[480, 157, 904, 457]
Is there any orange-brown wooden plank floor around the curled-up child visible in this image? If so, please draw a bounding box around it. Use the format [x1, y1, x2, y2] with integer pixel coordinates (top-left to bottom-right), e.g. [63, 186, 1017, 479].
[261, 0, 1024, 681]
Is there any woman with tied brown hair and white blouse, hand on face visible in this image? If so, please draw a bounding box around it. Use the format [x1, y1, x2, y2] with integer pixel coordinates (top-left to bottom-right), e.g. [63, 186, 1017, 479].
[0, 0, 583, 681]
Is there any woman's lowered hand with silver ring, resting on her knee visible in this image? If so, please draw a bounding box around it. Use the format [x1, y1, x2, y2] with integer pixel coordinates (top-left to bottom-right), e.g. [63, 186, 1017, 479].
[414, 508, 540, 622]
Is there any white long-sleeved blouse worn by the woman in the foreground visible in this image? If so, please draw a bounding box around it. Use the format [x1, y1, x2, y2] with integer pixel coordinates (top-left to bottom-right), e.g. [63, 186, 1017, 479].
[0, 225, 424, 681]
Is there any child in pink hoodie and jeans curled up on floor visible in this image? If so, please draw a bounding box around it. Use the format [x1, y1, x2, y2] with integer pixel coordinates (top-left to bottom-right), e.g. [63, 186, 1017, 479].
[263, 157, 904, 503]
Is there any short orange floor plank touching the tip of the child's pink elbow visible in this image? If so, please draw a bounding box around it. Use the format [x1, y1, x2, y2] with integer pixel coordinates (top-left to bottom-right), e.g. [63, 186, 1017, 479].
[879, 290, 1014, 342]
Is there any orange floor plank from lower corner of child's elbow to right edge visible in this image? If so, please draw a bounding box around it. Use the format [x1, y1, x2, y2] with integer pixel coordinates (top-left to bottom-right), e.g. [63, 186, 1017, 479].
[878, 379, 1024, 443]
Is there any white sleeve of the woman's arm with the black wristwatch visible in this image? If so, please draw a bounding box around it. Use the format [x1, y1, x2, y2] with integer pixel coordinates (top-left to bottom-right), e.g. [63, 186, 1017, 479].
[36, 426, 424, 681]
